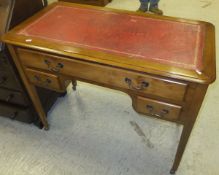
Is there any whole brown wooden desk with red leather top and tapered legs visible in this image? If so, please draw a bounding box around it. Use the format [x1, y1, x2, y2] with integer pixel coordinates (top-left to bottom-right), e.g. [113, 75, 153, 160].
[3, 2, 216, 173]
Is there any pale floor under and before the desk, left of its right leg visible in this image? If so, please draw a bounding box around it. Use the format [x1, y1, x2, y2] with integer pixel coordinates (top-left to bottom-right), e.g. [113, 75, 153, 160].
[0, 83, 181, 175]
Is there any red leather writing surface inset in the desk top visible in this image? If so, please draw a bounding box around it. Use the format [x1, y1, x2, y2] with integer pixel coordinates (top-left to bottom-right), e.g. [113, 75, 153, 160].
[19, 5, 204, 71]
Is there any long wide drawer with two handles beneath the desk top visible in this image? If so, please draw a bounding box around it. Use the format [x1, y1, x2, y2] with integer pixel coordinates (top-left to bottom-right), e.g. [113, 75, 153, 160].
[18, 49, 187, 101]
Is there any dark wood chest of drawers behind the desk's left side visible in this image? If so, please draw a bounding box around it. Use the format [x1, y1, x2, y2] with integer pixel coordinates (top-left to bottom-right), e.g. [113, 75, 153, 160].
[0, 0, 62, 124]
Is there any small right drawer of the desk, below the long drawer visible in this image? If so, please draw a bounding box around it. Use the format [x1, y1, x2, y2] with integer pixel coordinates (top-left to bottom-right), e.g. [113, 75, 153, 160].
[135, 97, 182, 120]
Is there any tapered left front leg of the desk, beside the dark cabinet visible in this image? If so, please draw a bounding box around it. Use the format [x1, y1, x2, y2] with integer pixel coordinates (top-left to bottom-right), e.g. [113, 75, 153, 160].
[7, 45, 49, 130]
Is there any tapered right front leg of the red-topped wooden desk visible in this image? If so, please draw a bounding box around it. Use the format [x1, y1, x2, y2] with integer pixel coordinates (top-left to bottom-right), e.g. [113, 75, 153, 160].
[170, 85, 208, 174]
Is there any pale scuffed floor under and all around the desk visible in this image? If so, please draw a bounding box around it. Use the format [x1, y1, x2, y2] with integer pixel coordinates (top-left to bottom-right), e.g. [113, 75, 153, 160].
[0, 0, 219, 175]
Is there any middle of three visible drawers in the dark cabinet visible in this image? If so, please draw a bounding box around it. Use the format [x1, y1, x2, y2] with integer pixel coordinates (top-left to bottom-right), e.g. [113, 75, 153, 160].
[0, 88, 28, 106]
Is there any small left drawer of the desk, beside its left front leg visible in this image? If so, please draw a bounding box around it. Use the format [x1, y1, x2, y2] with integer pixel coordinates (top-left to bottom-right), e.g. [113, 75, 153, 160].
[26, 68, 62, 91]
